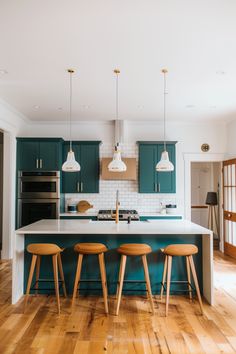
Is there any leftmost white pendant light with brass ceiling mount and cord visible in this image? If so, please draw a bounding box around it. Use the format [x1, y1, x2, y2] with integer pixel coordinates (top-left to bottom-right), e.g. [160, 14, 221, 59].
[62, 69, 80, 172]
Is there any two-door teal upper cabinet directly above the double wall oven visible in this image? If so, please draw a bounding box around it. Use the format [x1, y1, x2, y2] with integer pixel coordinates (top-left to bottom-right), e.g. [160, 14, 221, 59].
[17, 138, 63, 171]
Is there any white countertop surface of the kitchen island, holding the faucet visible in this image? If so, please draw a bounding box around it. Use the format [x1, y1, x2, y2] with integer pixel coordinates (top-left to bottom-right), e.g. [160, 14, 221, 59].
[16, 219, 212, 235]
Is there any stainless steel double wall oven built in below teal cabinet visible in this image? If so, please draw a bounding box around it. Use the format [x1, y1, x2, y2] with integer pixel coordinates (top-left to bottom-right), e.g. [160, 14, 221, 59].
[17, 171, 60, 227]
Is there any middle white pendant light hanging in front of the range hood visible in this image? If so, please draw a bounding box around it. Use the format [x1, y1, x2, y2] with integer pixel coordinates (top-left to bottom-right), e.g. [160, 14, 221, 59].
[108, 69, 127, 172]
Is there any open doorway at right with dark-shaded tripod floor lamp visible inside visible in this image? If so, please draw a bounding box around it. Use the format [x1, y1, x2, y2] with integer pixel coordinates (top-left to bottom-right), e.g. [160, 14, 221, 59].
[191, 162, 221, 249]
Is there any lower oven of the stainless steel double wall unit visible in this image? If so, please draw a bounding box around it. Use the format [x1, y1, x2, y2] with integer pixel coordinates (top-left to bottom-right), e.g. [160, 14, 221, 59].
[18, 198, 60, 227]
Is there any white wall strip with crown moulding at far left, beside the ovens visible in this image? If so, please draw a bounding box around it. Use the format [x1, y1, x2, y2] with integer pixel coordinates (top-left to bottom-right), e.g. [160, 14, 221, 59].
[0, 100, 27, 259]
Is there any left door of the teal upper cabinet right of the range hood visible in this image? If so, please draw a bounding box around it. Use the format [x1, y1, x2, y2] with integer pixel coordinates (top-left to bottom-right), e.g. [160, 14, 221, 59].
[139, 144, 157, 193]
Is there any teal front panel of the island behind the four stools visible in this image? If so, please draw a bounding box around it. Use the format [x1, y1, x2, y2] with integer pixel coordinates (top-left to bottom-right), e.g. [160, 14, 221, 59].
[24, 234, 203, 295]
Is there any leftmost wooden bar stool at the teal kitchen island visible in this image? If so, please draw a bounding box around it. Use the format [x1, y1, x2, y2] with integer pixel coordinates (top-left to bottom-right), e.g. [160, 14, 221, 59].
[25, 243, 66, 314]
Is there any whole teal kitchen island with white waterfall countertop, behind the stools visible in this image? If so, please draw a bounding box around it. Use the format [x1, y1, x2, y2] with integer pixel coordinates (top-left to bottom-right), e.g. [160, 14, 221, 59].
[12, 219, 213, 304]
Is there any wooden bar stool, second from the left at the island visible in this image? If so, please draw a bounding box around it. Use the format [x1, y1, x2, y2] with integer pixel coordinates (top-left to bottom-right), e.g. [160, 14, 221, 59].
[72, 243, 108, 314]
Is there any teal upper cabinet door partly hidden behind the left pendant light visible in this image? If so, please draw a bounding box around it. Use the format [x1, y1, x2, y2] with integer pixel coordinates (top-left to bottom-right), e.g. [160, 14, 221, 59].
[62, 144, 80, 193]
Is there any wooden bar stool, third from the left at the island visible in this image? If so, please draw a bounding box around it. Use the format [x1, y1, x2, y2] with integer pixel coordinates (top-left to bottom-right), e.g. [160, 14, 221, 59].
[116, 243, 154, 316]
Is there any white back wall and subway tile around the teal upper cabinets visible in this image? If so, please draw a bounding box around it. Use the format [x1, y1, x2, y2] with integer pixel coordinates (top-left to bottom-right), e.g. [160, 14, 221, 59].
[19, 121, 227, 215]
